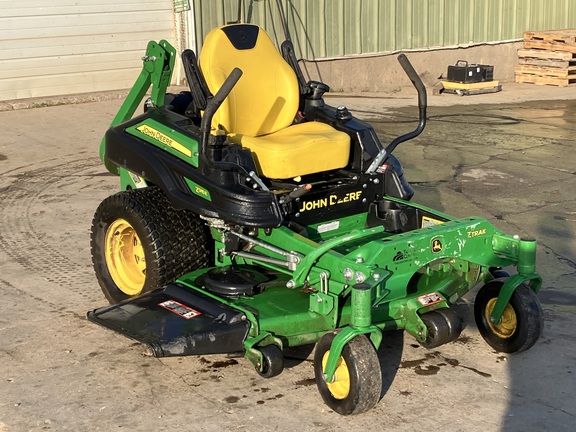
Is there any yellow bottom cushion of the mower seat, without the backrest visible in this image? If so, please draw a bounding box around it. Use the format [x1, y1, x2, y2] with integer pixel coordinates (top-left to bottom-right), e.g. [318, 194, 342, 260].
[230, 122, 350, 179]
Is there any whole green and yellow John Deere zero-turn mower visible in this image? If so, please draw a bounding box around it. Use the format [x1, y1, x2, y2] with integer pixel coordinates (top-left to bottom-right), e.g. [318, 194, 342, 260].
[88, 24, 543, 415]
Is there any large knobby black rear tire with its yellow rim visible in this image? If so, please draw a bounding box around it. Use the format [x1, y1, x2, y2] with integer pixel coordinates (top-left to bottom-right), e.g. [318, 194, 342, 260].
[91, 187, 211, 304]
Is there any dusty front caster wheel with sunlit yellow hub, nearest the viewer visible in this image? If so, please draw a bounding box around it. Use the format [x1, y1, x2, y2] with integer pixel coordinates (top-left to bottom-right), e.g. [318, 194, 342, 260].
[314, 333, 382, 415]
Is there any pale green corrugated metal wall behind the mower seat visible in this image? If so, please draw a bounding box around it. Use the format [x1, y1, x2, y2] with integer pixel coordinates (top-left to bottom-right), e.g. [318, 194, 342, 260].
[192, 0, 576, 59]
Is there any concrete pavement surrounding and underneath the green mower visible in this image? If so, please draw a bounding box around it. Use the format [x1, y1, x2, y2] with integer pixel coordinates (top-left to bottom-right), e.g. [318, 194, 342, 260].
[0, 85, 576, 432]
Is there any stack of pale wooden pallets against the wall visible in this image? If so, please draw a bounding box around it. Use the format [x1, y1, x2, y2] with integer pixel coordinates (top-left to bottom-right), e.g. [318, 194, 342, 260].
[515, 29, 576, 87]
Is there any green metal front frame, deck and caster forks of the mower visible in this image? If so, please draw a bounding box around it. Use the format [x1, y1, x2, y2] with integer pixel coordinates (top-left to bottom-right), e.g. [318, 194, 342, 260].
[173, 209, 541, 381]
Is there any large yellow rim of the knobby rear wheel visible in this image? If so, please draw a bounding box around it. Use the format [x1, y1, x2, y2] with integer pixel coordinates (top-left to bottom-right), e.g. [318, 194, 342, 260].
[105, 219, 146, 296]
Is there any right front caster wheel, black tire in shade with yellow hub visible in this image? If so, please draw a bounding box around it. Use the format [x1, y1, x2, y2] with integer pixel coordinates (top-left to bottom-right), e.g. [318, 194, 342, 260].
[474, 279, 544, 353]
